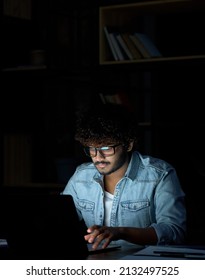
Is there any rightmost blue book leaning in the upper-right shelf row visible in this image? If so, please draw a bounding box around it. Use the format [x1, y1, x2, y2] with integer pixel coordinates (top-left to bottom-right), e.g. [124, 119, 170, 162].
[134, 32, 162, 57]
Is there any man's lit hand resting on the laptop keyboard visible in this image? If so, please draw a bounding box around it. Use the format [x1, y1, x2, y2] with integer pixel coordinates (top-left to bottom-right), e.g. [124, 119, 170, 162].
[84, 225, 119, 249]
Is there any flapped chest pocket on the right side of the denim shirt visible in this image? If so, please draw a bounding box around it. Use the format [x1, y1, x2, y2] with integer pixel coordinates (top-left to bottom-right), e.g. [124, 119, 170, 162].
[120, 200, 150, 227]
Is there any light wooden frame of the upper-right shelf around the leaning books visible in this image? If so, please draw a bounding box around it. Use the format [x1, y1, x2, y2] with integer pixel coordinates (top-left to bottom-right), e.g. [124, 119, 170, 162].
[99, 0, 205, 65]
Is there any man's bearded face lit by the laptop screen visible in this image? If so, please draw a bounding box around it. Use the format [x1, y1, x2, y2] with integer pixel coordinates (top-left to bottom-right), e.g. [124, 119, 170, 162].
[89, 145, 128, 175]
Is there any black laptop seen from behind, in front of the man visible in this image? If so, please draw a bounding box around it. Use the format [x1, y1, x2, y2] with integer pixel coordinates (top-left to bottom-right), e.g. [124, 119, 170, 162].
[1, 194, 89, 260]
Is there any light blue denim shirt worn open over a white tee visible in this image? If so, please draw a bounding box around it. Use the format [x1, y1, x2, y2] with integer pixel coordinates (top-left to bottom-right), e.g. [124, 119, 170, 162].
[62, 151, 186, 245]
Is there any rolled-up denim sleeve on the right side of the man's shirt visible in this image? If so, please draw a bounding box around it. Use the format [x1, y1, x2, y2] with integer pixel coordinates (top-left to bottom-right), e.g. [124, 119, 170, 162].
[151, 169, 186, 245]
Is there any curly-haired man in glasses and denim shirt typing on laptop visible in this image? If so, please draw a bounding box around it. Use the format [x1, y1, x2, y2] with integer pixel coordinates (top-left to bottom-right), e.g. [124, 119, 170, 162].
[63, 104, 186, 249]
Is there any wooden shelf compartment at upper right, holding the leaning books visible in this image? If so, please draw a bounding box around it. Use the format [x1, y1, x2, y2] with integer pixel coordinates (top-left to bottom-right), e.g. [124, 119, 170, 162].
[99, 0, 205, 65]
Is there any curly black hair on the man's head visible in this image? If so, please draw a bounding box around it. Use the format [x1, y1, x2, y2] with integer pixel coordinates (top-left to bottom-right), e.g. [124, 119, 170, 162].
[75, 104, 137, 146]
